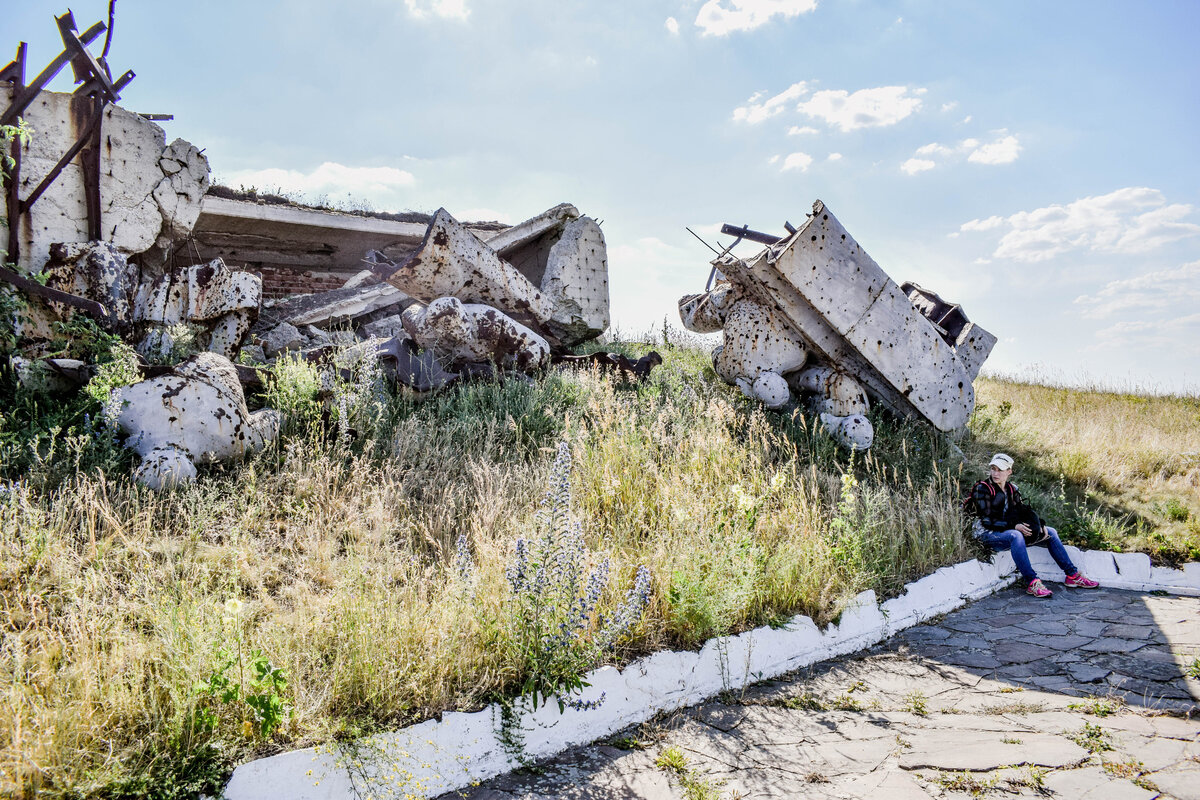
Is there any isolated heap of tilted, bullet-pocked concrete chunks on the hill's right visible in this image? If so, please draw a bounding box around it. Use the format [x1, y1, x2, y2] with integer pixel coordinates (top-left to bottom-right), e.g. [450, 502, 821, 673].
[679, 200, 996, 450]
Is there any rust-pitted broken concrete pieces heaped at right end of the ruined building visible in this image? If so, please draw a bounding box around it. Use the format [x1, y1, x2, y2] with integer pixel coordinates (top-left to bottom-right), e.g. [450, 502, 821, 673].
[251, 204, 608, 381]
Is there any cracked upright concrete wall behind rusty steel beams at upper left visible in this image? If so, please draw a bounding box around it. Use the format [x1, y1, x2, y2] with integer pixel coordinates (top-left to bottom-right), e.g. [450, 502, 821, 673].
[0, 84, 209, 272]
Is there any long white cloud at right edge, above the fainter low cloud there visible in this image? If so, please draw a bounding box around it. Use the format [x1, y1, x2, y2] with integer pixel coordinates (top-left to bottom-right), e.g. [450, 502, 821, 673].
[961, 187, 1200, 263]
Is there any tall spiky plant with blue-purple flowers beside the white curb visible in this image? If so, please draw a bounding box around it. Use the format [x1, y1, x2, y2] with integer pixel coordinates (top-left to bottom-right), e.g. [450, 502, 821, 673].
[505, 443, 650, 711]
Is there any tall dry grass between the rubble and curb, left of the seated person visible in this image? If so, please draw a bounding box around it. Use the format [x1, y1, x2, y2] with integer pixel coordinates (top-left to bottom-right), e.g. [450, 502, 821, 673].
[0, 351, 965, 796]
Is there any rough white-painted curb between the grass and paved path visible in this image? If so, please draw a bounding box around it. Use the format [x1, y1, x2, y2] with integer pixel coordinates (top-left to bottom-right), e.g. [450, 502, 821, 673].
[224, 547, 1200, 800]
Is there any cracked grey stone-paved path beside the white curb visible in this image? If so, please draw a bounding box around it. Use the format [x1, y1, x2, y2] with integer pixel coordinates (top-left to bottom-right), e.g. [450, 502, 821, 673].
[448, 587, 1200, 800]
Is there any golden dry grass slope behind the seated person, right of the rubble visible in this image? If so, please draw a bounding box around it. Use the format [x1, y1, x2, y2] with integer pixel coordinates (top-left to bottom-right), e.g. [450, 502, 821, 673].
[972, 378, 1200, 563]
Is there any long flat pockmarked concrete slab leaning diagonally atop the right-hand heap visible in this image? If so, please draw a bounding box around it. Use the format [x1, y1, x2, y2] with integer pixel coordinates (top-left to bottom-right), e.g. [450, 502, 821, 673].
[716, 200, 984, 431]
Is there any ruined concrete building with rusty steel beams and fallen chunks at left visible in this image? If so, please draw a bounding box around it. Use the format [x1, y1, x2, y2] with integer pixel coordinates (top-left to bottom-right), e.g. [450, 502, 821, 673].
[0, 12, 608, 488]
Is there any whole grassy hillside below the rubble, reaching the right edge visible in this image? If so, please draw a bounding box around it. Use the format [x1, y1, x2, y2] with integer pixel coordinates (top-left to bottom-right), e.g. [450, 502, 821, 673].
[0, 335, 1200, 798]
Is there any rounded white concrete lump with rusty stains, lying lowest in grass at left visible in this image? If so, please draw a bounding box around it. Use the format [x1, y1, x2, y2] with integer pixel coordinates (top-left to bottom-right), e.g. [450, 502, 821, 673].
[109, 353, 281, 489]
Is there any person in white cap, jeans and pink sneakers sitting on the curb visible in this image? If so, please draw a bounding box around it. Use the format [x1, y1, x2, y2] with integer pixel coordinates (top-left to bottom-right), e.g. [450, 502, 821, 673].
[971, 453, 1099, 597]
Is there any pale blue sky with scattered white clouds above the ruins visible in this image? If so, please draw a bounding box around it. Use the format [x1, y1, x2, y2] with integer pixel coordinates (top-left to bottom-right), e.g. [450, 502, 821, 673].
[9, 0, 1200, 393]
